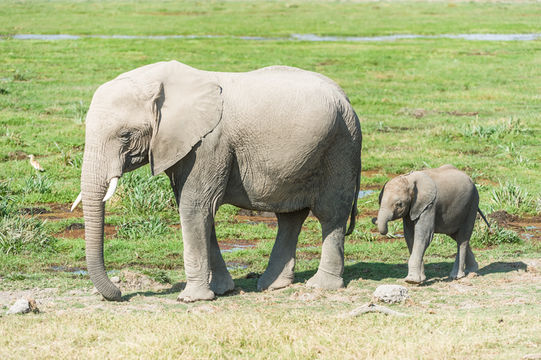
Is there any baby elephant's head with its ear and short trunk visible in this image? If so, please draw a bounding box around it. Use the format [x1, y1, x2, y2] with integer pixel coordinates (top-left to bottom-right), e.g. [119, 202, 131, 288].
[372, 171, 437, 235]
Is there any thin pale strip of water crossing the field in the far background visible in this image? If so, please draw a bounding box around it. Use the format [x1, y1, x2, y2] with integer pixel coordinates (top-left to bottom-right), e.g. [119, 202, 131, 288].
[5, 33, 541, 42]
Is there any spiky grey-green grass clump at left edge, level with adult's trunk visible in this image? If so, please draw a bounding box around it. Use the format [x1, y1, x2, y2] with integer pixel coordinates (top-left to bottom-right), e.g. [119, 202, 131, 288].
[0, 216, 55, 254]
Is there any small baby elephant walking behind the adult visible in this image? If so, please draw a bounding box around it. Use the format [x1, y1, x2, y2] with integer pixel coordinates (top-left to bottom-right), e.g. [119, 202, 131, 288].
[372, 165, 488, 284]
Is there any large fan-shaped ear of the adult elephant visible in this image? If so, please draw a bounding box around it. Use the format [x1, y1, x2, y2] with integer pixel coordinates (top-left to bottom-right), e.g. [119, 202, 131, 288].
[149, 61, 223, 175]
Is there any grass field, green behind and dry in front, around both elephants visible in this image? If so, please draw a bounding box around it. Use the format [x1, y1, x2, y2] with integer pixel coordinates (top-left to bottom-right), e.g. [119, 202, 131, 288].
[0, 1, 541, 359]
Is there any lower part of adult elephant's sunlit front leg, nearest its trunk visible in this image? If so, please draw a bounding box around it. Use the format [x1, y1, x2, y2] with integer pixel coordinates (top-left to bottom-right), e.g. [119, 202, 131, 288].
[178, 206, 214, 302]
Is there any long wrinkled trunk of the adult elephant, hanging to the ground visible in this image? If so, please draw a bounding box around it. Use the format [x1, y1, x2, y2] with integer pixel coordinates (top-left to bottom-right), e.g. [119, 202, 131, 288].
[81, 144, 121, 301]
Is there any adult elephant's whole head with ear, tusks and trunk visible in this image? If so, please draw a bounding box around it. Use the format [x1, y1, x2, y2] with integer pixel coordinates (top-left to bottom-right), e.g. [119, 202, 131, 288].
[73, 61, 222, 300]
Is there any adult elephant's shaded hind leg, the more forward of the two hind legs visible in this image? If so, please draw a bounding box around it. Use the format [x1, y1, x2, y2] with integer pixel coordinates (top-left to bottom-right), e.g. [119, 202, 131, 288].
[257, 209, 309, 291]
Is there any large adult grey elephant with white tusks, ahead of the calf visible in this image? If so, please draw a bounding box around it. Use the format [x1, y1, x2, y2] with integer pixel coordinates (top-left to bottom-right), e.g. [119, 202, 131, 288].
[77, 61, 361, 301]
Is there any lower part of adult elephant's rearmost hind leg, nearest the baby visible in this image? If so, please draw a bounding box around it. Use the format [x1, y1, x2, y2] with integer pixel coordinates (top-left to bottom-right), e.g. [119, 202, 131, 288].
[306, 221, 346, 290]
